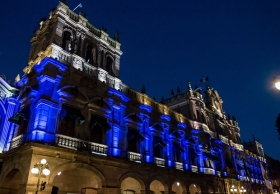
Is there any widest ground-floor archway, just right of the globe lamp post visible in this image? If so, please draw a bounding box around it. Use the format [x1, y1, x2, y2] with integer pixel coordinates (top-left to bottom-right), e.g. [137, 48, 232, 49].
[52, 168, 102, 194]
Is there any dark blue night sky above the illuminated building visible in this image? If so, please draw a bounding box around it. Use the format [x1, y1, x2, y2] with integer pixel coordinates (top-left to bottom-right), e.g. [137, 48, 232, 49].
[0, 0, 280, 159]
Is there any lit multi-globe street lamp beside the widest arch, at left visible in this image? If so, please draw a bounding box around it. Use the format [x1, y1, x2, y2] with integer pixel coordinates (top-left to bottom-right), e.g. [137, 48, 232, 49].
[31, 159, 50, 194]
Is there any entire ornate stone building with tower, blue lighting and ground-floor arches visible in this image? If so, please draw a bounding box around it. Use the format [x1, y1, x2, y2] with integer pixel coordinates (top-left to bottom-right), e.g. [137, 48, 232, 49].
[0, 2, 272, 194]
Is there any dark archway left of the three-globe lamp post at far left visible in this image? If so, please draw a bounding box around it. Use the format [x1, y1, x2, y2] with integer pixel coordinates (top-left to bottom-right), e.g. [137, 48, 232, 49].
[0, 169, 23, 194]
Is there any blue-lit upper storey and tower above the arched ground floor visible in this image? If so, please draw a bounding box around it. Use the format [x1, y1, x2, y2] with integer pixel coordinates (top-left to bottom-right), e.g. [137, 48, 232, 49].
[0, 3, 272, 192]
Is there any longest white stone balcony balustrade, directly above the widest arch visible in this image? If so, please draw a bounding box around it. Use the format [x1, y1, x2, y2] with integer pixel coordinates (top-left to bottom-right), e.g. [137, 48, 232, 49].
[56, 135, 108, 156]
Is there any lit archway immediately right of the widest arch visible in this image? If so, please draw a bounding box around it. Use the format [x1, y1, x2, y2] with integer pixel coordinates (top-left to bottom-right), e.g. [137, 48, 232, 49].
[121, 177, 141, 194]
